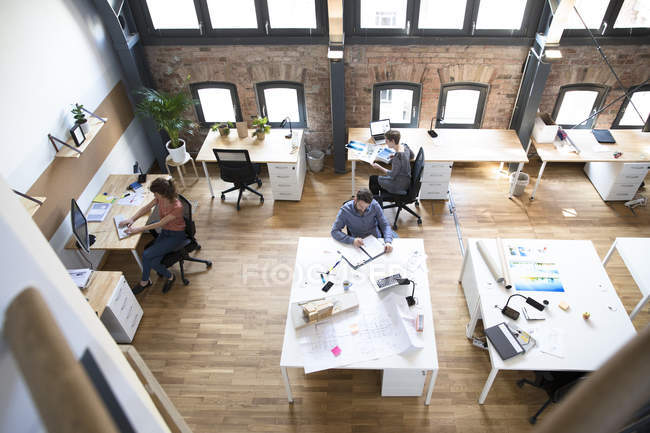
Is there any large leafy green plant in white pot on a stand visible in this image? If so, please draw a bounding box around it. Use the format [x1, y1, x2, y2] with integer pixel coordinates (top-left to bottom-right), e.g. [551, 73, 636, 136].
[136, 87, 195, 163]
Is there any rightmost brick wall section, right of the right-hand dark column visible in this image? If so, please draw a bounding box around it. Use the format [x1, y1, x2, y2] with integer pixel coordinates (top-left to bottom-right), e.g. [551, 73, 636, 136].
[539, 45, 650, 128]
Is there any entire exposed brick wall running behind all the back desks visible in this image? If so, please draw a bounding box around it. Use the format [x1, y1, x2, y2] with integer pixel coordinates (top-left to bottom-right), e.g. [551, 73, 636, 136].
[145, 45, 650, 151]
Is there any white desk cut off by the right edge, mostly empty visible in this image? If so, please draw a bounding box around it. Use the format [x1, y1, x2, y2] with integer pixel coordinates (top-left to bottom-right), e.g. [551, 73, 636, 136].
[603, 238, 650, 319]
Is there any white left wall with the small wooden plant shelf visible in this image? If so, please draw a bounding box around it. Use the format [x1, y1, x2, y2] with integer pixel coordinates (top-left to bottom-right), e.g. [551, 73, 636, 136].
[0, 0, 154, 265]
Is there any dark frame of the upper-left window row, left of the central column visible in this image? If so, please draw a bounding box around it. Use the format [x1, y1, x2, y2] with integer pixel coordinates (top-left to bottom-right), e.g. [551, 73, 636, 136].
[130, 0, 329, 45]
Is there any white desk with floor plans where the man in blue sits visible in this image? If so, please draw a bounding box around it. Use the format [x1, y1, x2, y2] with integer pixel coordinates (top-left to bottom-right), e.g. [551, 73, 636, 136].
[280, 237, 438, 405]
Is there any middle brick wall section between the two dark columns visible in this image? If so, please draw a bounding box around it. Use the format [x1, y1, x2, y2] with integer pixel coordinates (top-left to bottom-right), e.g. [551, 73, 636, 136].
[345, 45, 528, 128]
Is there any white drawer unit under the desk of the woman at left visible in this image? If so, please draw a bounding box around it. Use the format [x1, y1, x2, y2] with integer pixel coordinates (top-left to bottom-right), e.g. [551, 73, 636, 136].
[101, 276, 142, 343]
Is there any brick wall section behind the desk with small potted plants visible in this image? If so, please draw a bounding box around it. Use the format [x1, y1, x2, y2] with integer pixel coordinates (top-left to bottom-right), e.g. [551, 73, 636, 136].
[145, 45, 332, 152]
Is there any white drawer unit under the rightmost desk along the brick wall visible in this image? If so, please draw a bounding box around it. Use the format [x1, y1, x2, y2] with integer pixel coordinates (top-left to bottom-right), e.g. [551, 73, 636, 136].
[584, 162, 650, 201]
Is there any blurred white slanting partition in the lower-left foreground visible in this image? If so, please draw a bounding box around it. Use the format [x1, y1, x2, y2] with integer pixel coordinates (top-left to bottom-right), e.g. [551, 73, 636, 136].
[0, 174, 169, 433]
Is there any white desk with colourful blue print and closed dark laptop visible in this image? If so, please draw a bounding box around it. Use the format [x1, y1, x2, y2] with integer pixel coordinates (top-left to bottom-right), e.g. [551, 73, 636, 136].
[460, 239, 636, 404]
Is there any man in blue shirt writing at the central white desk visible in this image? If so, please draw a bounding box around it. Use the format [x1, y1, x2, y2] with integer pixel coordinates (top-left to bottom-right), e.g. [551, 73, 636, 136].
[332, 188, 397, 253]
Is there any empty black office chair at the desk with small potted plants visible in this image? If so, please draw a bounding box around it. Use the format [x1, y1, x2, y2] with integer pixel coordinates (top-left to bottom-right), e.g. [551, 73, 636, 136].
[212, 149, 264, 210]
